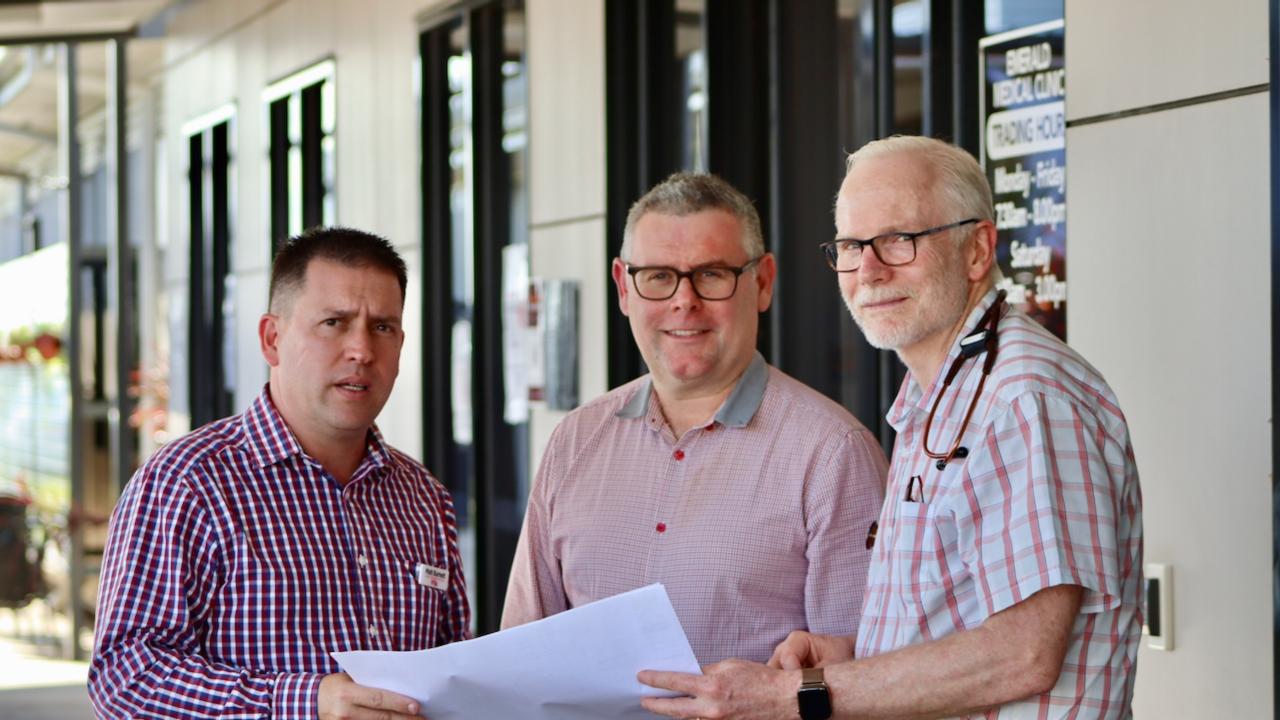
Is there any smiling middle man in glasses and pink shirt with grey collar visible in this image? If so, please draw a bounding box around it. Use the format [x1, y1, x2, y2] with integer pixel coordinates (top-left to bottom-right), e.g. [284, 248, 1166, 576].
[503, 173, 886, 662]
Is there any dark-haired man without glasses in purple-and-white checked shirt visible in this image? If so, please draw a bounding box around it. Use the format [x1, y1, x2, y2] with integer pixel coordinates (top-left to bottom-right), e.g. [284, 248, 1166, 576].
[88, 228, 470, 720]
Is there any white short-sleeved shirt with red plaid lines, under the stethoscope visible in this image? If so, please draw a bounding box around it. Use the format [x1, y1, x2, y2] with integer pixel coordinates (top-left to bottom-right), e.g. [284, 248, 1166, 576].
[858, 292, 1142, 717]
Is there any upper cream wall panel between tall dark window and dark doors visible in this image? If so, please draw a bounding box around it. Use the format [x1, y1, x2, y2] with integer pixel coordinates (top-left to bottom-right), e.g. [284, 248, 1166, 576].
[526, 0, 605, 224]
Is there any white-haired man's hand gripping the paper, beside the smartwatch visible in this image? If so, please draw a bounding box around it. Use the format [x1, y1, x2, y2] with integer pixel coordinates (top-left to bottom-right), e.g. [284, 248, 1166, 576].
[637, 660, 800, 720]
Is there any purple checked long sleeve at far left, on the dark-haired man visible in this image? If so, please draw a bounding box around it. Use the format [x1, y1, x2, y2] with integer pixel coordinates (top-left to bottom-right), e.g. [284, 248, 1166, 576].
[88, 469, 323, 720]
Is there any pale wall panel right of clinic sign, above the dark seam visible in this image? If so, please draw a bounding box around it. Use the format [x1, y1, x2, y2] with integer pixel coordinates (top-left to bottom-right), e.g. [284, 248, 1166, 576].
[1066, 0, 1268, 119]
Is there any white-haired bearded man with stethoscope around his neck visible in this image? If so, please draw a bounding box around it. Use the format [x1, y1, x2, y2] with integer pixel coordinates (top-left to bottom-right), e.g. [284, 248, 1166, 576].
[640, 137, 1142, 720]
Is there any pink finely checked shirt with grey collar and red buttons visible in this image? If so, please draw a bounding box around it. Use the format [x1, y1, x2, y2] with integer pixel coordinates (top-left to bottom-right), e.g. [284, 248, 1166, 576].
[502, 355, 886, 664]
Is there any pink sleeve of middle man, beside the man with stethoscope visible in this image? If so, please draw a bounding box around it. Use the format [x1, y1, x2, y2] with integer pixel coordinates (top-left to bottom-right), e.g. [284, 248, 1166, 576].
[804, 428, 888, 635]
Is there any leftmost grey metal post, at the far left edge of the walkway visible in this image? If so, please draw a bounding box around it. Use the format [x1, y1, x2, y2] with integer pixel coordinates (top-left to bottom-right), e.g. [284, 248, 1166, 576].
[58, 42, 84, 660]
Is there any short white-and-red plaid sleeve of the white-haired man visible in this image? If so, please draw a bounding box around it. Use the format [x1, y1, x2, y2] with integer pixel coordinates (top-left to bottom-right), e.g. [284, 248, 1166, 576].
[956, 393, 1135, 615]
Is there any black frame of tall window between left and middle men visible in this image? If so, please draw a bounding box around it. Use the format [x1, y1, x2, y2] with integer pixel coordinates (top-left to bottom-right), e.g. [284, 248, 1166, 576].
[419, 0, 527, 634]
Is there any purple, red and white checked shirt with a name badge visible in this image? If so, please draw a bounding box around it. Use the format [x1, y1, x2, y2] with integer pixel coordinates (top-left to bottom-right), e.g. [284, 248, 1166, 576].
[88, 389, 470, 719]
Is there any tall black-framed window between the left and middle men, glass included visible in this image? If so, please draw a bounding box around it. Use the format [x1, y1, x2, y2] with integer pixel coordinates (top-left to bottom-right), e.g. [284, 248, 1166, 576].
[420, 1, 529, 633]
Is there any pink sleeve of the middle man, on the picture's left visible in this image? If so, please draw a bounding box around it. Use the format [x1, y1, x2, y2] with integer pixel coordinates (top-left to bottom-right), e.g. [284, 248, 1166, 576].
[502, 428, 568, 629]
